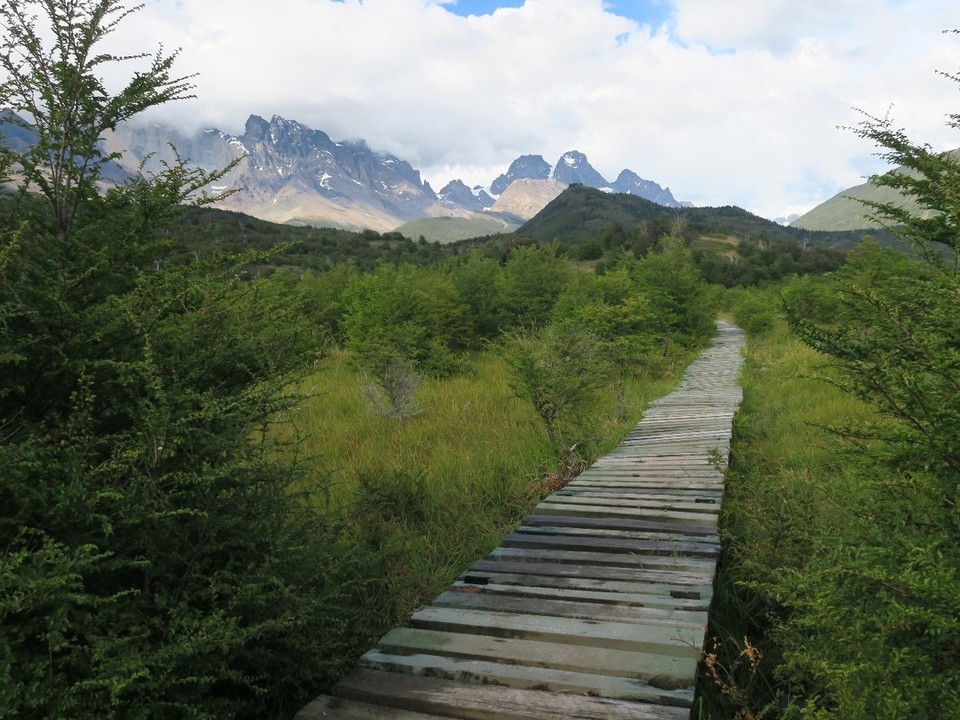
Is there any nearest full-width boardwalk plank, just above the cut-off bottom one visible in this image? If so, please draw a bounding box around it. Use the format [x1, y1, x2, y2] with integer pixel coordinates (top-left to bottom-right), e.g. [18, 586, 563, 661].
[334, 668, 690, 720]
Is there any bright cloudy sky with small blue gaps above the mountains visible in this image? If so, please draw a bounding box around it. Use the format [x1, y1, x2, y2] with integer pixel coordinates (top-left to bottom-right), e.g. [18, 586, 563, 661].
[101, 0, 960, 217]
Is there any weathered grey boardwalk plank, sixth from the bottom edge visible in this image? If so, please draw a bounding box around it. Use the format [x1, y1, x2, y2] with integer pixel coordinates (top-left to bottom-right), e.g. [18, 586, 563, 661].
[430, 588, 707, 627]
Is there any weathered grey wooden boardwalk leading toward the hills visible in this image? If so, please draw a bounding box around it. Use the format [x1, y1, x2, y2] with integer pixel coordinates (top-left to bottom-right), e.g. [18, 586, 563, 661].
[296, 323, 743, 720]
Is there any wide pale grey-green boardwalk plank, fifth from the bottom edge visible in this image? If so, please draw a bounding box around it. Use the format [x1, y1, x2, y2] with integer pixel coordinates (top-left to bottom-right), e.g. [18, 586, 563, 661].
[410, 606, 706, 658]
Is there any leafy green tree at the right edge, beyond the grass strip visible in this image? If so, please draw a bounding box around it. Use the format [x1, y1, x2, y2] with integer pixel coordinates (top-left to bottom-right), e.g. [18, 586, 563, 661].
[773, 49, 960, 718]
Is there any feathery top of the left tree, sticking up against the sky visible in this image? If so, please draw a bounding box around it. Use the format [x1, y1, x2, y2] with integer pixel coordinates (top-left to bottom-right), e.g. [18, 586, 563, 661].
[0, 0, 193, 242]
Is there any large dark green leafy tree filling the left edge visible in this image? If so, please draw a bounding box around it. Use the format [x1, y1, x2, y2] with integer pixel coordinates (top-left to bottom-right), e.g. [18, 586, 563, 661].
[0, 0, 362, 718]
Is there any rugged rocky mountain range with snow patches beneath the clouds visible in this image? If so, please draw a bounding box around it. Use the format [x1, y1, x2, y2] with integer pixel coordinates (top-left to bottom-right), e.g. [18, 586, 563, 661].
[95, 115, 681, 239]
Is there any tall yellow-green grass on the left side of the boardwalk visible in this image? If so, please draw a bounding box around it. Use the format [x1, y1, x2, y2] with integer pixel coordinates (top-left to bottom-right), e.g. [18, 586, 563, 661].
[281, 350, 683, 690]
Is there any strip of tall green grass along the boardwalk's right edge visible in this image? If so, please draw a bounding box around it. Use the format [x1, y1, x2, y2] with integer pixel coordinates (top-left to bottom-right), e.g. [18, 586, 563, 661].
[694, 319, 871, 719]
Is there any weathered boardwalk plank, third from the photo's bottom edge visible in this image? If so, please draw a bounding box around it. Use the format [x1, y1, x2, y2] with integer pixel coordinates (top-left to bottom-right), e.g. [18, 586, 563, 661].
[359, 650, 693, 707]
